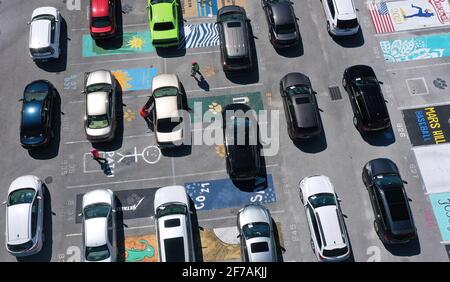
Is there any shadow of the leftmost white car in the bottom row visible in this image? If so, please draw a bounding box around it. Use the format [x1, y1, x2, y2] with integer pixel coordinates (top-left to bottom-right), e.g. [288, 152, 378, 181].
[17, 184, 56, 262]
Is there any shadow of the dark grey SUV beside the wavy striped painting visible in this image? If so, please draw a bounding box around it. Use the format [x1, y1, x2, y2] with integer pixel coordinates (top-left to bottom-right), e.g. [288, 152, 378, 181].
[225, 23, 259, 84]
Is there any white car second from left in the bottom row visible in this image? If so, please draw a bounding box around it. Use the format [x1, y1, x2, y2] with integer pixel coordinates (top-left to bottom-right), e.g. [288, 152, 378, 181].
[80, 189, 117, 262]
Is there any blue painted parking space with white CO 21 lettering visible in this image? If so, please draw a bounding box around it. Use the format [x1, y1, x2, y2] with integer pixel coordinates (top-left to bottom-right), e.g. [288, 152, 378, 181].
[185, 175, 276, 211]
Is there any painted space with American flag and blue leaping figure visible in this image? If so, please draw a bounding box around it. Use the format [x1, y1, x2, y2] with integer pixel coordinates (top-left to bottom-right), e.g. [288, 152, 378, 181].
[368, 0, 450, 33]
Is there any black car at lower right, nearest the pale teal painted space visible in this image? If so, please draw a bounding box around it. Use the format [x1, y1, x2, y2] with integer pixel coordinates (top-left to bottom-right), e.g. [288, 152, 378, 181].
[362, 159, 417, 244]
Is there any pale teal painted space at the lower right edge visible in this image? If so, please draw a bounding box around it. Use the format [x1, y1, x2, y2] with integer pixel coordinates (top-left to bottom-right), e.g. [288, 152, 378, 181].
[430, 192, 450, 244]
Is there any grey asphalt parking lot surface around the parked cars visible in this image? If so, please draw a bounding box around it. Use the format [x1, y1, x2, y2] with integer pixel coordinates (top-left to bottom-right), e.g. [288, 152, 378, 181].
[0, 0, 450, 262]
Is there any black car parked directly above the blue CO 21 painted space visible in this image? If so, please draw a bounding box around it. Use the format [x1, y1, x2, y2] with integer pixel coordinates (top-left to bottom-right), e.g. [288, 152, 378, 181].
[222, 104, 261, 180]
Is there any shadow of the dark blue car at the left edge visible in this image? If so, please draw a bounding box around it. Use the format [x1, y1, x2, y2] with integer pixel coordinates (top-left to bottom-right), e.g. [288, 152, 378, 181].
[28, 89, 64, 160]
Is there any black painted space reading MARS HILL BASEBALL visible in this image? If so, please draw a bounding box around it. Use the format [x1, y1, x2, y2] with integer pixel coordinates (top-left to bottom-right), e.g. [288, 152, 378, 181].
[402, 105, 450, 146]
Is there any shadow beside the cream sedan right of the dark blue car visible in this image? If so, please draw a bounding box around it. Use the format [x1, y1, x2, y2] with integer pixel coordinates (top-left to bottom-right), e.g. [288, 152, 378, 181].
[92, 80, 126, 152]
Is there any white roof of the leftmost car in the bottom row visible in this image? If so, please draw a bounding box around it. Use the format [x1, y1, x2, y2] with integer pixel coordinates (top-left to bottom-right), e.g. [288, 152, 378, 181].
[7, 204, 30, 244]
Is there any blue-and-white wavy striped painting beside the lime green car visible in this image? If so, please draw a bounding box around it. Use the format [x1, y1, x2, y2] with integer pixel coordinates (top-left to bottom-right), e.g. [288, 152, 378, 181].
[180, 23, 219, 48]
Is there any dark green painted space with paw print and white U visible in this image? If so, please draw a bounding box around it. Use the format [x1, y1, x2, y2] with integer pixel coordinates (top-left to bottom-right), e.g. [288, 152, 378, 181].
[188, 92, 264, 122]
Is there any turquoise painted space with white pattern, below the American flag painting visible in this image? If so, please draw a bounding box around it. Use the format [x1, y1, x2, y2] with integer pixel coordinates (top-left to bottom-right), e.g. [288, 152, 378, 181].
[380, 33, 450, 63]
